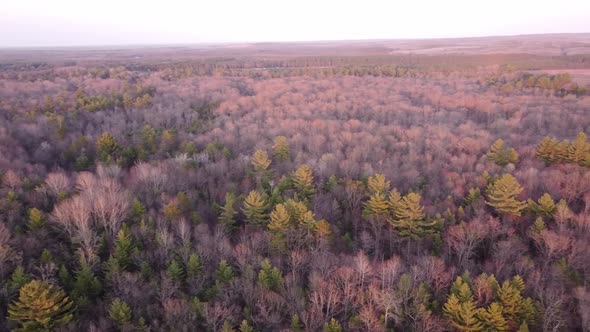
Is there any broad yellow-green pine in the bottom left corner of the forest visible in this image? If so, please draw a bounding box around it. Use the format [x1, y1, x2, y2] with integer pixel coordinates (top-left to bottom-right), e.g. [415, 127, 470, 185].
[8, 280, 74, 331]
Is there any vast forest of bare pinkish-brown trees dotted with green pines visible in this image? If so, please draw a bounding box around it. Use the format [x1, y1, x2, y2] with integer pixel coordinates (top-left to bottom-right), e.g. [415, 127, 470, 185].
[0, 37, 590, 332]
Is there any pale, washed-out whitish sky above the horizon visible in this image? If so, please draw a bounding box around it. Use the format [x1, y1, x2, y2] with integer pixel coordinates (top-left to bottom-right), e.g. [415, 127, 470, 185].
[0, 0, 590, 47]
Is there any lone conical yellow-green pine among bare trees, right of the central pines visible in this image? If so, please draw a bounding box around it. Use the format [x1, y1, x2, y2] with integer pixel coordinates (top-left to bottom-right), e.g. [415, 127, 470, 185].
[486, 174, 526, 216]
